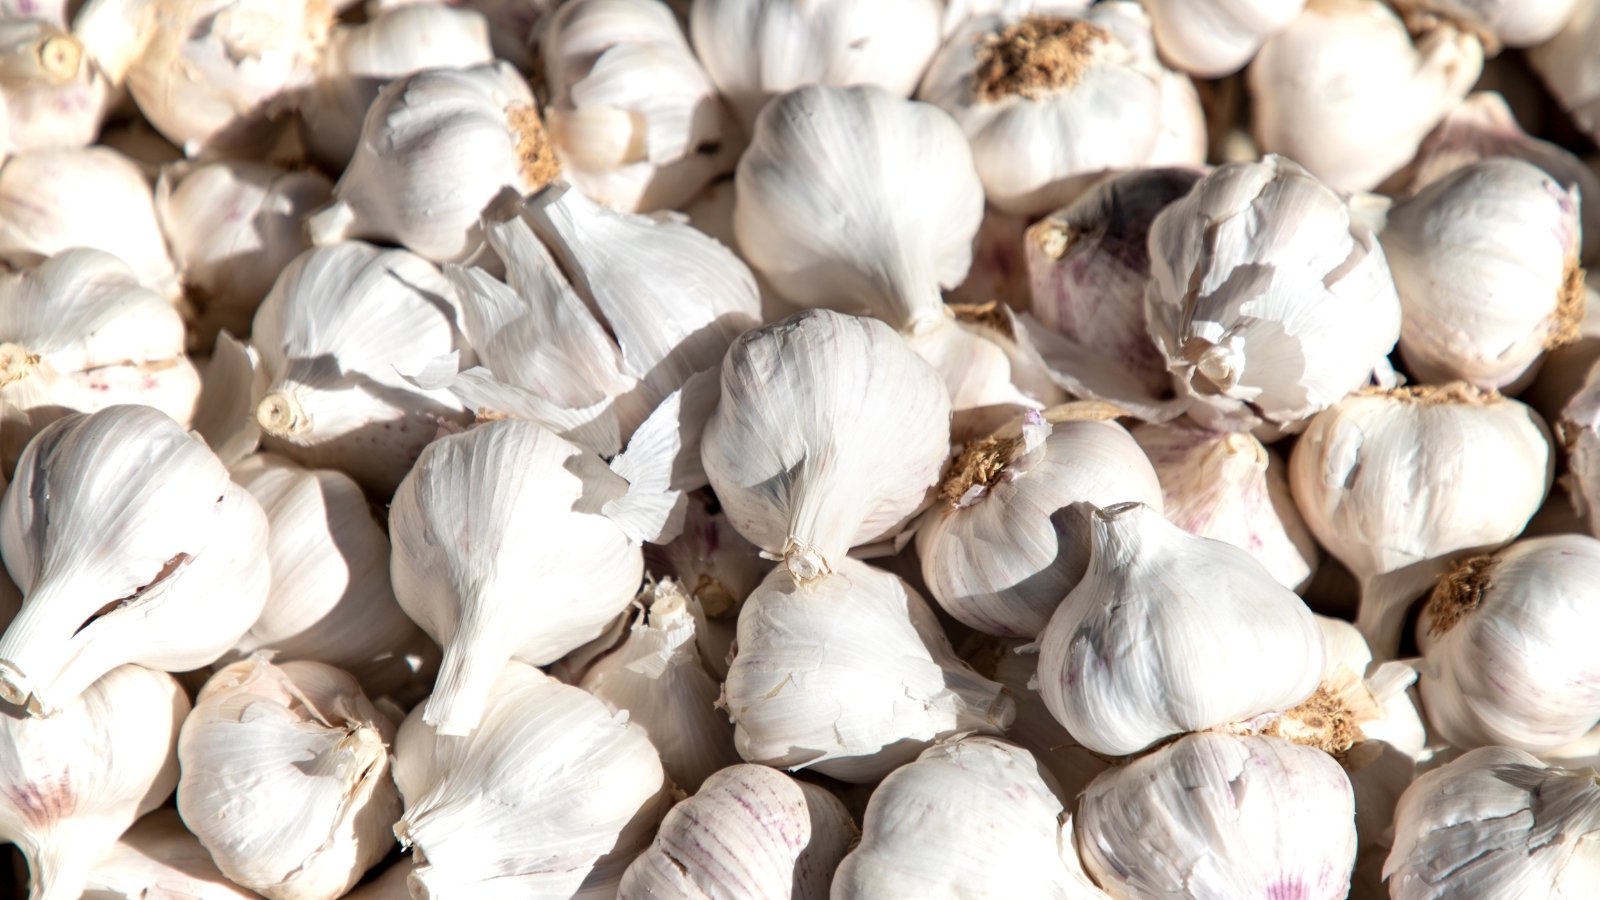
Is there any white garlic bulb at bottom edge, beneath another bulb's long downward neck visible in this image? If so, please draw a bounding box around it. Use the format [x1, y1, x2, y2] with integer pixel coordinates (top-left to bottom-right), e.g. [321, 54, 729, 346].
[394, 663, 669, 898]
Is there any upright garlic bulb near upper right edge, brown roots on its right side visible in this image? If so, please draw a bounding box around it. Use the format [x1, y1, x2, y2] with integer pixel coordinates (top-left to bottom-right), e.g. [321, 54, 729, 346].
[1379, 159, 1584, 391]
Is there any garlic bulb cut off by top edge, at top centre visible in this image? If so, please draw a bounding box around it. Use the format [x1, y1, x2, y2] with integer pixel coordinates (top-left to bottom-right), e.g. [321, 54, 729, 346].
[690, 0, 944, 128]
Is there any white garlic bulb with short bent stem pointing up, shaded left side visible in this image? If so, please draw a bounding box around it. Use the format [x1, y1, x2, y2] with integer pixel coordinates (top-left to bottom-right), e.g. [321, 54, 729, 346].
[1038, 503, 1323, 756]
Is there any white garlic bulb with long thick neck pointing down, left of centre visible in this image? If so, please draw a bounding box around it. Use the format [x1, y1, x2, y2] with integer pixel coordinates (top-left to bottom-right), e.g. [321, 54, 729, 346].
[389, 420, 643, 735]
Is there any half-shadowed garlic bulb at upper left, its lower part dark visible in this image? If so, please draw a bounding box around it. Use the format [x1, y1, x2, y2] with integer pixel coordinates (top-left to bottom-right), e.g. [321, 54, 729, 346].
[155, 160, 333, 349]
